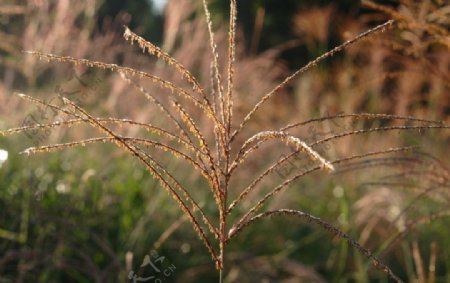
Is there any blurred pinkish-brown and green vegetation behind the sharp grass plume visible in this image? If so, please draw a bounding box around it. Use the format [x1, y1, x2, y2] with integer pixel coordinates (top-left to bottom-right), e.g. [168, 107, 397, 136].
[0, 0, 450, 282]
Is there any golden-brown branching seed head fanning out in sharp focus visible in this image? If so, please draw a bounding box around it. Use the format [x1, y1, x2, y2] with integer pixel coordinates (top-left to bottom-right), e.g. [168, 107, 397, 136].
[8, 0, 444, 282]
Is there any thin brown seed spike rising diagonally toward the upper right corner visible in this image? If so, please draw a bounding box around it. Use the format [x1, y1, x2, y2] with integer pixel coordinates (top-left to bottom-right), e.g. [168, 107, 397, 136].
[231, 20, 394, 140]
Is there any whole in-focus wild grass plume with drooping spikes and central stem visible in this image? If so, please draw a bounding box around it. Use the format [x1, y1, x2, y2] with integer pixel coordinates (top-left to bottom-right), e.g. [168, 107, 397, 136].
[1, 0, 450, 282]
